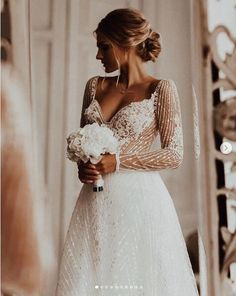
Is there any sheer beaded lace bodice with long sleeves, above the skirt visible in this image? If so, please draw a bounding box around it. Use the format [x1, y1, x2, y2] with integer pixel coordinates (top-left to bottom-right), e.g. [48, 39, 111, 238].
[81, 76, 183, 170]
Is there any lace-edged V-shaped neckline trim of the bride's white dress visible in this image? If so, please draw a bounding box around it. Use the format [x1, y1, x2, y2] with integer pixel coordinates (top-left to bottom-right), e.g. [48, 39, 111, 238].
[92, 76, 163, 124]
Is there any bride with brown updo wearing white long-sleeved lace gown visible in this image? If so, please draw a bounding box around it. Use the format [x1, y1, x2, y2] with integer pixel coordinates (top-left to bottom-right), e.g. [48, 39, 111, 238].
[57, 9, 198, 296]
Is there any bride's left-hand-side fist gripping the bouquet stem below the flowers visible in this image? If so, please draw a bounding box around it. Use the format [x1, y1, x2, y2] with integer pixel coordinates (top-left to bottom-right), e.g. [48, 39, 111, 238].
[77, 161, 100, 184]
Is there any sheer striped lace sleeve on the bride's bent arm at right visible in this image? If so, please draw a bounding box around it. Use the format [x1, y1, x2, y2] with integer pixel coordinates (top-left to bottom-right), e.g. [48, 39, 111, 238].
[120, 80, 183, 170]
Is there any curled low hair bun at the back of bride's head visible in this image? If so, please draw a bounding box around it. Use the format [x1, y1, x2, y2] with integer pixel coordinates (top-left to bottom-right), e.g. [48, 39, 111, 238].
[138, 31, 161, 62]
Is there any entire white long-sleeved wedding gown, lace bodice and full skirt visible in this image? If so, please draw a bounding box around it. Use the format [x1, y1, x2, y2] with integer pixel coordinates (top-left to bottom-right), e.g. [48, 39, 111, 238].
[56, 77, 198, 296]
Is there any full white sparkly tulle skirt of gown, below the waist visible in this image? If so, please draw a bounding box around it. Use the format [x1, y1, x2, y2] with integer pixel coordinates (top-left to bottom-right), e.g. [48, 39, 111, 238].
[56, 171, 198, 296]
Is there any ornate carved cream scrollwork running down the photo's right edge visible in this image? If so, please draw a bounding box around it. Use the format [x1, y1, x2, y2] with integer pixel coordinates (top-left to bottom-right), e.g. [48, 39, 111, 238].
[207, 25, 236, 296]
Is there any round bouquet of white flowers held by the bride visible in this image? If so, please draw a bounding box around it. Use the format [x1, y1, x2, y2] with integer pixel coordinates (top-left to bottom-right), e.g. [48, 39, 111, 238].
[67, 123, 118, 191]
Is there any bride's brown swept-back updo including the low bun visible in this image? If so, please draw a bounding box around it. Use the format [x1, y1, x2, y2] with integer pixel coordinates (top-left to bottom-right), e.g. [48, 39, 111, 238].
[94, 8, 161, 62]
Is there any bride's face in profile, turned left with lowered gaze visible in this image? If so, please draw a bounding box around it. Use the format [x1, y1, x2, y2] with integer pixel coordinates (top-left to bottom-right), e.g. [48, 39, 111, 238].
[96, 33, 124, 73]
